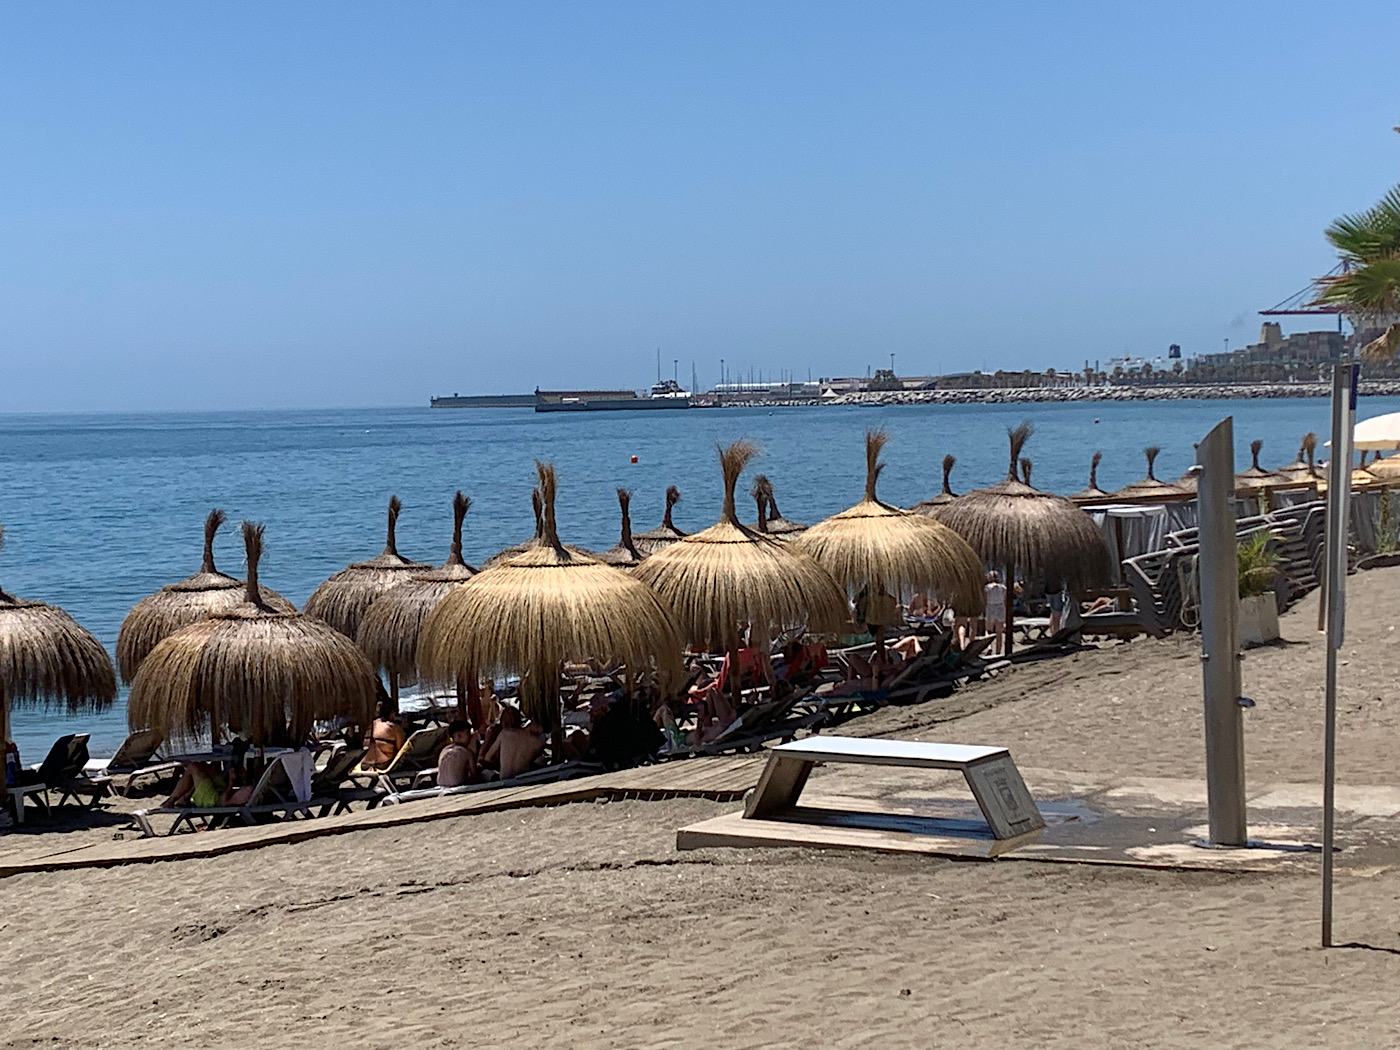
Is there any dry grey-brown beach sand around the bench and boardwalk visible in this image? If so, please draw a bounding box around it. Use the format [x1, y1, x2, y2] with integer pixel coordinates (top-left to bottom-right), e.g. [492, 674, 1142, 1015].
[0, 570, 1400, 1050]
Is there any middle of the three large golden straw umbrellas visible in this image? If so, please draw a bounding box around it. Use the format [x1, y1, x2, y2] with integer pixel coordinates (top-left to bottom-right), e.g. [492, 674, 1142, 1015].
[633, 441, 848, 703]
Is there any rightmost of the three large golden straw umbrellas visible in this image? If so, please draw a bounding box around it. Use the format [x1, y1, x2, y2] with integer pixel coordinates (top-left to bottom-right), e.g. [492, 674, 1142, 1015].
[792, 430, 983, 644]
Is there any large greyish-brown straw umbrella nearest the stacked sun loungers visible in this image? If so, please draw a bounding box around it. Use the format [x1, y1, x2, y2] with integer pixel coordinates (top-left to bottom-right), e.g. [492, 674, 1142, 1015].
[938, 421, 1113, 652]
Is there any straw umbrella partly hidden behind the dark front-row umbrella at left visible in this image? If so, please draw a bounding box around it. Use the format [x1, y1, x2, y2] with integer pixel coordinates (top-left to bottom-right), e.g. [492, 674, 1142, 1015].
[116, 508, 297, 683]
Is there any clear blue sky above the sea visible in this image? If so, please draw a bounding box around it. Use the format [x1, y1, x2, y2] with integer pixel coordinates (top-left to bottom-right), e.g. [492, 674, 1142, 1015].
[0, 0, 1400, 412]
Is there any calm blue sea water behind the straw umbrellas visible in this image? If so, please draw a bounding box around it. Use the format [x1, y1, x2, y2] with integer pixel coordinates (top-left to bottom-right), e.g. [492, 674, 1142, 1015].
[0, 398, 1400, 762]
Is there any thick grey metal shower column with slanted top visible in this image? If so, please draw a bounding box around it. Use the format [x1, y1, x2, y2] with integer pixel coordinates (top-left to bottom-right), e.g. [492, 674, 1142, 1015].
[1196, 417, 1247, 846]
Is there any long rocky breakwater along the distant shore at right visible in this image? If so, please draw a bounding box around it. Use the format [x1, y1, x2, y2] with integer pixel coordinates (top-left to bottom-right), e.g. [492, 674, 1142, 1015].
[721, 379, 1400, 409]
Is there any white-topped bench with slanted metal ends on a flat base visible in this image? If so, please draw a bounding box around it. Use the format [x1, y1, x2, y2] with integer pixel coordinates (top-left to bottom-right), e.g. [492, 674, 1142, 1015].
[676, 736, 1046, 857]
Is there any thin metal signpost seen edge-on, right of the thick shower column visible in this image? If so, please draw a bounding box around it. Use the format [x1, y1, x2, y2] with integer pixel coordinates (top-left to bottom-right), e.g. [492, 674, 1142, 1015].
[1322, 357, 1361, 948]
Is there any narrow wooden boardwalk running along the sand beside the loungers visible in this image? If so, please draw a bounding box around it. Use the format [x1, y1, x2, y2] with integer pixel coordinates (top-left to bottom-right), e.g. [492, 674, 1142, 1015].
[0, 756, 763, 878]
